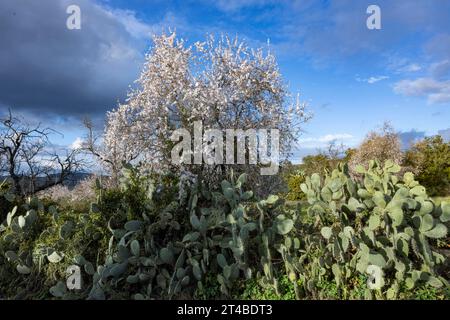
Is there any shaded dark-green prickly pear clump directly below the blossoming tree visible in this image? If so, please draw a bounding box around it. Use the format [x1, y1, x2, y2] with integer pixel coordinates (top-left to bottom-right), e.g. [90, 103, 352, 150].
[83, 168, 288, 299]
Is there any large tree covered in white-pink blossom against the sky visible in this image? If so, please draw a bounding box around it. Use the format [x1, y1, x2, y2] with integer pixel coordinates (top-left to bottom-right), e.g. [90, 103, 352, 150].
[99, 33, 308, 186]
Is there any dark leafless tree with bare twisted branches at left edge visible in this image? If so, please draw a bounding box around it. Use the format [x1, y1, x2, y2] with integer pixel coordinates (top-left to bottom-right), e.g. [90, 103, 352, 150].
[0, 111, 84, 195]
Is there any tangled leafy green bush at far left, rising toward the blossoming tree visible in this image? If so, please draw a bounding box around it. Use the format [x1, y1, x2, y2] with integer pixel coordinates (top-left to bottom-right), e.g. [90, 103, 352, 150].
[0, 168, 163, 299]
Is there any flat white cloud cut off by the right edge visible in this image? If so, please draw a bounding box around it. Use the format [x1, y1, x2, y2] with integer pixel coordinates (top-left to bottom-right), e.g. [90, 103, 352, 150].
[394, 78, 450, 104]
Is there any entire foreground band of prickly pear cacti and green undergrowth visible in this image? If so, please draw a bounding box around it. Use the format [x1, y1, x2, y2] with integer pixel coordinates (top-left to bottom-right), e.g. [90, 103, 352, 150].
[0, 161, 450, 300]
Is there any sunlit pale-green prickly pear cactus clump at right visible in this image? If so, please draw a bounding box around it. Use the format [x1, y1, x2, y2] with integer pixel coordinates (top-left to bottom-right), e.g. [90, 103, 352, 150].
[268, 161, 450, 299]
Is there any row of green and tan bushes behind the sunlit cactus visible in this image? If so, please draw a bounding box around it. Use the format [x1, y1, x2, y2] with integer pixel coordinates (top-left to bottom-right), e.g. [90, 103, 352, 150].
[282, 131, 450, 201]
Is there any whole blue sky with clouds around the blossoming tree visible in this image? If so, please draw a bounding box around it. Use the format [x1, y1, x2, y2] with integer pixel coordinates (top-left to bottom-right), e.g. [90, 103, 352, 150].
[0, 0, 450, 161]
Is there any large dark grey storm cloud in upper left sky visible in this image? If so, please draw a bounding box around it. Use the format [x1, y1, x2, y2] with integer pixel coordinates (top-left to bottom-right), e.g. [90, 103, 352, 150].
[0, 0, 152, 117]
